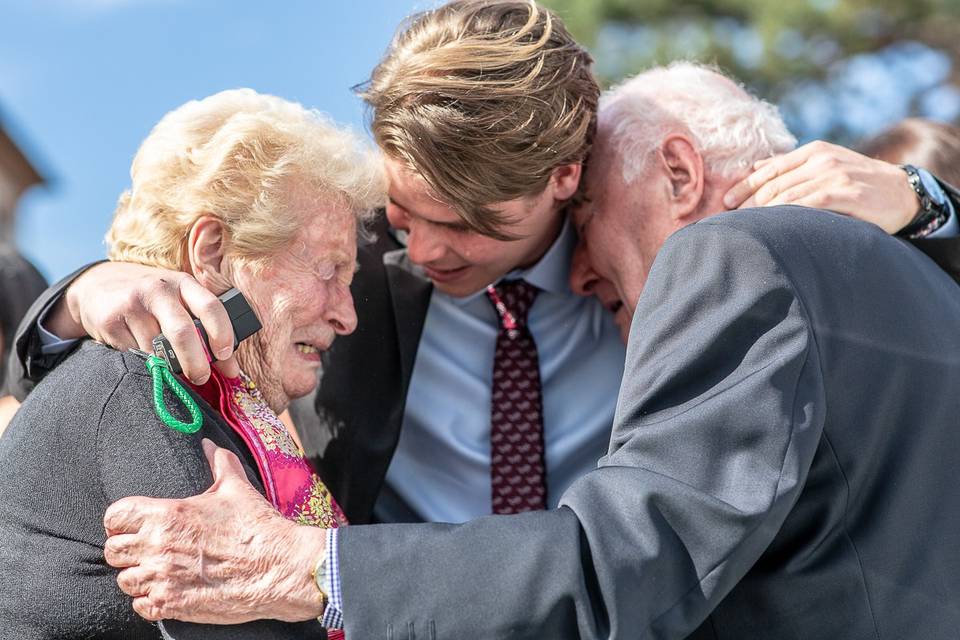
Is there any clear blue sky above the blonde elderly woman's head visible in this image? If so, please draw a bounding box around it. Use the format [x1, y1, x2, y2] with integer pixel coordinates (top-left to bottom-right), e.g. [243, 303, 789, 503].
[0, 0, 426, 279]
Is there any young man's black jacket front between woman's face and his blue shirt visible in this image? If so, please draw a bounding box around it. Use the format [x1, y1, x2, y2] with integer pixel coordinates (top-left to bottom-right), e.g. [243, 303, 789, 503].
[290, 217, 433, 524]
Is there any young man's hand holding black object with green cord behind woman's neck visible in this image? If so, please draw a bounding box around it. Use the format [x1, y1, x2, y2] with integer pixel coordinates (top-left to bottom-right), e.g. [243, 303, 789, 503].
[55, 262, 233, 384]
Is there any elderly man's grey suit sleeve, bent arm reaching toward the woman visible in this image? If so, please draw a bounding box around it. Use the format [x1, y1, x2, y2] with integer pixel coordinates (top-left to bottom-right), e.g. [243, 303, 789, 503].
[340, 224, 824, 639]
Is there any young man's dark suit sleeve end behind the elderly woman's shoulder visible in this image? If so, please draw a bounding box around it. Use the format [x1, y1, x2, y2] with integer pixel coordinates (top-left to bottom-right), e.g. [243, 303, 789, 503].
[4, 261, 102, 402]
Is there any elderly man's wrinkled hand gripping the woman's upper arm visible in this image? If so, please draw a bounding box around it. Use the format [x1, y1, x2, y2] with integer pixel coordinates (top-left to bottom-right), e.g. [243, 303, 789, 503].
[103, 440, 326, 624]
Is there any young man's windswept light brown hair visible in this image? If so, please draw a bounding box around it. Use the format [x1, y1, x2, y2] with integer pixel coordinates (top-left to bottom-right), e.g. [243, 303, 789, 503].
[360, 0, 600, 239]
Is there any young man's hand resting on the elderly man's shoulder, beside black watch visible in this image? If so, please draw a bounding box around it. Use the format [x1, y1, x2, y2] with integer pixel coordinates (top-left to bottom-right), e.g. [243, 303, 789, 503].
[723, 140, 920, 233]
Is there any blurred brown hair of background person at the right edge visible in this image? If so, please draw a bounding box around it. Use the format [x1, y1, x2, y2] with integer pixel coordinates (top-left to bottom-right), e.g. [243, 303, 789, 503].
[858, 118, 960, 185]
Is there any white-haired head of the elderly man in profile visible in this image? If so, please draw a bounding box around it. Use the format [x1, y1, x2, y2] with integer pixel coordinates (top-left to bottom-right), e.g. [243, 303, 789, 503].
[571, 62, 797, 341]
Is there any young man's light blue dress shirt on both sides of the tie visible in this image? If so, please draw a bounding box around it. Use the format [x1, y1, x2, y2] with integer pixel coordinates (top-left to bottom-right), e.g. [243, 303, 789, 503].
[375, 218, 625, 522]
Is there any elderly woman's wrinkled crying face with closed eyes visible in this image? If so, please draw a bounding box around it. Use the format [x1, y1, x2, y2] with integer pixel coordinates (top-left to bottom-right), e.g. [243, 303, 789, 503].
[234, 196, 357, 413]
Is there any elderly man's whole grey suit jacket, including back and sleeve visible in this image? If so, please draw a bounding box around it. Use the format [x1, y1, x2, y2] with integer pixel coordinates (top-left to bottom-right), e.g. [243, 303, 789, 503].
[340, 207, 960, 640]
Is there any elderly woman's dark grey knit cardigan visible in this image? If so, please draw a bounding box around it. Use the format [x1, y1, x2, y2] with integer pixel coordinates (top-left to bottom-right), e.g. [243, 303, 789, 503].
[0, 342, 325, 640]
